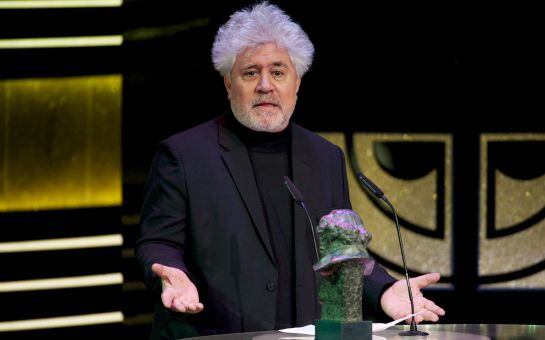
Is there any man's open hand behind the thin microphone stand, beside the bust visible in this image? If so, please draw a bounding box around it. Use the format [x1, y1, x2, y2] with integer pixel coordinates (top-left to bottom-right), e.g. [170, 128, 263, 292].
[380, 273, 445, 323]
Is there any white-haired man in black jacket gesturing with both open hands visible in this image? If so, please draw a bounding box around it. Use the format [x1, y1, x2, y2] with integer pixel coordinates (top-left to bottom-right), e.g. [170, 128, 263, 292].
[136, 2, 444, 338]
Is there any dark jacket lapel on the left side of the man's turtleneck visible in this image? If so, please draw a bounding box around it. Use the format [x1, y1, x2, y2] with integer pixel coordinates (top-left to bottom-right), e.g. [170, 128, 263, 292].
[218, 121, 276, 266]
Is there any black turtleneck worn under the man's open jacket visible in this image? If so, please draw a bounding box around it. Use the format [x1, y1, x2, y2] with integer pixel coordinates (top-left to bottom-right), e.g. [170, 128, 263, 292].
[224, 115, 296, 329]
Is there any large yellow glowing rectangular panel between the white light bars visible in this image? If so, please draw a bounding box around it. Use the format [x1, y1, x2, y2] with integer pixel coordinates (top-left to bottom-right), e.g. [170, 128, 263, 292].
[0, 74, 122, 212]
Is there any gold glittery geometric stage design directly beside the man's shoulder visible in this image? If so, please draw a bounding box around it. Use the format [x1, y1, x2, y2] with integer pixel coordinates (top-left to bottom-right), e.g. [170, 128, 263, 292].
[320, 132, 452, 277]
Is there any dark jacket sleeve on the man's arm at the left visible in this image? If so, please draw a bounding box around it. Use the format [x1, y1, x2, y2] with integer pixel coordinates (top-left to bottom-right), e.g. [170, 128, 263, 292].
[135, 141, 191, 295]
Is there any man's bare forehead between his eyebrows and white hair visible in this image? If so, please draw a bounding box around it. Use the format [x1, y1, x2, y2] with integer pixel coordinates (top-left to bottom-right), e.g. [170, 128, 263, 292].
[235, 43, 293, 67]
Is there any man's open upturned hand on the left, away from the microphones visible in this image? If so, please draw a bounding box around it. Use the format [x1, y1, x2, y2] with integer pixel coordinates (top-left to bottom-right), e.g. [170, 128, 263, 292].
[151, 263, 204, 314]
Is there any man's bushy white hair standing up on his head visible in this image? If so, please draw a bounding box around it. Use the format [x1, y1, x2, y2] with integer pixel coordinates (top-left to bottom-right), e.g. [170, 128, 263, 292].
[212, 1, 314, 78]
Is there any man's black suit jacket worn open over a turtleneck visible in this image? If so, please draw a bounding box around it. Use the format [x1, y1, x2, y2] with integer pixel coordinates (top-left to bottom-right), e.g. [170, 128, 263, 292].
[136, 117, 394, 338]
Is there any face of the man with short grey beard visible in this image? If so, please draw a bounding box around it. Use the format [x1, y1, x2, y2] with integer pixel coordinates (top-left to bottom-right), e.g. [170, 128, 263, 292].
[224, 43, 301, 132]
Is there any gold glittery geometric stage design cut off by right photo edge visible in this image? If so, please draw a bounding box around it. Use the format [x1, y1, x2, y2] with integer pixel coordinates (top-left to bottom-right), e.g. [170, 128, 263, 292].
[478, 133, 545, 289]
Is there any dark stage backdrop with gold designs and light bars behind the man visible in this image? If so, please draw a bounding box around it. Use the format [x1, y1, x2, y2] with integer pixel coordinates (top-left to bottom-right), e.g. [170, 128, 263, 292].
[0, 0, 545, 338]
